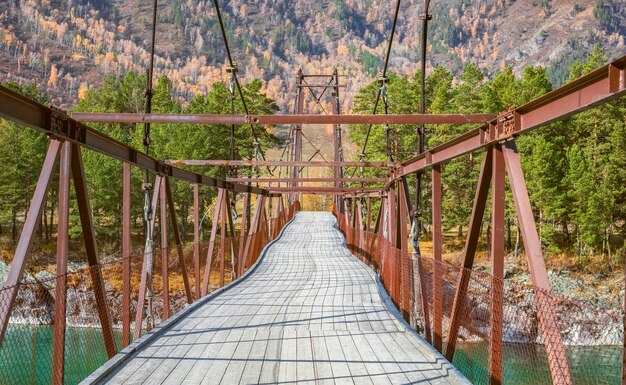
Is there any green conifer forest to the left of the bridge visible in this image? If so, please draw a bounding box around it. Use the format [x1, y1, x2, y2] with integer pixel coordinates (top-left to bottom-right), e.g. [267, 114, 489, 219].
[0, 72, 281, 260]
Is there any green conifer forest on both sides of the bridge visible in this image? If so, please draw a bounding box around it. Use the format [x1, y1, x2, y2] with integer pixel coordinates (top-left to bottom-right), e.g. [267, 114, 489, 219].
[0, 46, 626, 268]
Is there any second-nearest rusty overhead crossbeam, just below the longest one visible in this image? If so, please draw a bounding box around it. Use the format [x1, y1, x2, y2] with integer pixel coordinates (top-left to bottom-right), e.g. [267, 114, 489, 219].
[165, 159, 398, 168]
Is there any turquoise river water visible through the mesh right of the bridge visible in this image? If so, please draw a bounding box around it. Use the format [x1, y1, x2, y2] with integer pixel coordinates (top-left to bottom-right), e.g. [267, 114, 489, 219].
[453, 343, 622, 385]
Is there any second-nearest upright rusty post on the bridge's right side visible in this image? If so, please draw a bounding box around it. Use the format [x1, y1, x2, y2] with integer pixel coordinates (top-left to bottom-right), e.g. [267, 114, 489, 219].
[431, 164, 443, 352]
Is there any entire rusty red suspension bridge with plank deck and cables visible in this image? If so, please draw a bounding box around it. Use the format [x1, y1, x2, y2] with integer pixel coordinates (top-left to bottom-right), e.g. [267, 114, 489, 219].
[0, 0, 626, 384]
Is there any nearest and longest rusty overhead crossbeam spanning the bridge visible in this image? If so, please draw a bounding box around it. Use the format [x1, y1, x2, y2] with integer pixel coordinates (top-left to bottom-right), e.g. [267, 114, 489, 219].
[72, 111, 495, 126]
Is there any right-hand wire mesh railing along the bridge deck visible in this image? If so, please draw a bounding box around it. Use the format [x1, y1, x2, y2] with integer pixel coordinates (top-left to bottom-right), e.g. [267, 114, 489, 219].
[334, 210, 624, 384]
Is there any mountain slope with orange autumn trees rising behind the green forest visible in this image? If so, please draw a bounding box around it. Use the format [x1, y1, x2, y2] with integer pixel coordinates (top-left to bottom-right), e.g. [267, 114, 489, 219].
[0, 0, 626, 112]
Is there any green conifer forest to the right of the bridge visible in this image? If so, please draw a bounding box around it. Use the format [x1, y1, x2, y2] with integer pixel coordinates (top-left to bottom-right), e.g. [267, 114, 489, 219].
[349, 45, 626, 267]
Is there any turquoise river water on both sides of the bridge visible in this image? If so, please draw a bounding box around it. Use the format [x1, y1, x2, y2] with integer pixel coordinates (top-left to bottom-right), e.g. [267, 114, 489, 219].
[0, 325, 622, 385]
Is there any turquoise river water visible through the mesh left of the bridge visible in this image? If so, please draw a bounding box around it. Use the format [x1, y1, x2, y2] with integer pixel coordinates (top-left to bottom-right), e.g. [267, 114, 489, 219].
[0, 325, 121, 385]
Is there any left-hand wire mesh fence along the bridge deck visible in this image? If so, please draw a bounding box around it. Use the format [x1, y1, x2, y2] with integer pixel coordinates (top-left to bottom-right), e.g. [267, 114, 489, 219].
[0, 201, 297, 384]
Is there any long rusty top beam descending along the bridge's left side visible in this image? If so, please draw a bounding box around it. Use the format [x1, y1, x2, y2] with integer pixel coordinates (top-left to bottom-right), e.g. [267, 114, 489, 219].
[0, 86, 267, 194]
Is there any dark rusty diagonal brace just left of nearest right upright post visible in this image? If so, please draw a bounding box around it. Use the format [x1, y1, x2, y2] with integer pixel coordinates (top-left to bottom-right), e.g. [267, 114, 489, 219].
[445, 147, 493, 362]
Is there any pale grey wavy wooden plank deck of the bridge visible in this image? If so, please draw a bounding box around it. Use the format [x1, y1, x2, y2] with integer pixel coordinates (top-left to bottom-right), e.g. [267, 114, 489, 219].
[91, 212, 466, 384]
